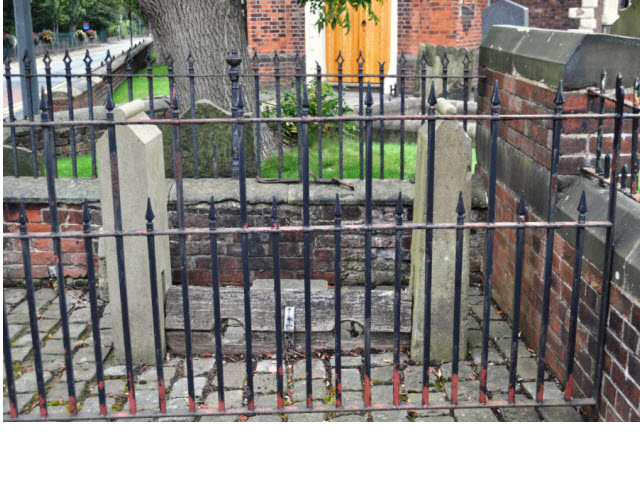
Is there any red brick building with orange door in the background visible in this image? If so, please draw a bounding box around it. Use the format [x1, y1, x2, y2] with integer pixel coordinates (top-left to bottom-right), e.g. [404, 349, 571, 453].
[246, 0, 628, 80]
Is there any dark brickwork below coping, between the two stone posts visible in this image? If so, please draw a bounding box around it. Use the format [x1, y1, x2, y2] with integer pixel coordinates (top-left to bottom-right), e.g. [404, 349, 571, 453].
[169, 202, 411, 285]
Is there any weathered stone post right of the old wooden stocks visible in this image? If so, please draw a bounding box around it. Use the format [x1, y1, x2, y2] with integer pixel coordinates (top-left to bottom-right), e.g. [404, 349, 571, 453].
[409, 99, 471, 361]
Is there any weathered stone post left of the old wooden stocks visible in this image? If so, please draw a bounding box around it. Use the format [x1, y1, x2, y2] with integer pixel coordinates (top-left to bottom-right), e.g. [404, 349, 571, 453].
[96, 100, 171, 363]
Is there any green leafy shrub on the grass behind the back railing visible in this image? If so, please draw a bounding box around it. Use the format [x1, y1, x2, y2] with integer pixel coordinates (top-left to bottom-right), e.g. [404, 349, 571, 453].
[262, 78, 356, 139]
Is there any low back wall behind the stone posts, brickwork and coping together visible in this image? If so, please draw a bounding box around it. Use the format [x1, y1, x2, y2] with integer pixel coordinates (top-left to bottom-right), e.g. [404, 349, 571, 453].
[3, 177, 413, 285]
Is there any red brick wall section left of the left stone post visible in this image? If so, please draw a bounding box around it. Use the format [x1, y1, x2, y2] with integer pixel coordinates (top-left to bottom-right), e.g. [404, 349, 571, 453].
[2, 203, 102, 281]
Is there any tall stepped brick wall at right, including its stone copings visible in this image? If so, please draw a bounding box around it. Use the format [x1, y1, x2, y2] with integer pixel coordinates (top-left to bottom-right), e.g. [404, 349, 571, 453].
[476, 27, 640, 421]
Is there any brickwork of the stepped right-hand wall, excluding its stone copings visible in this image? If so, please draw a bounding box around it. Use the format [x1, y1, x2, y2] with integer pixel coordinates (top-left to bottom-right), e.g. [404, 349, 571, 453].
[478, 66, 640, 421]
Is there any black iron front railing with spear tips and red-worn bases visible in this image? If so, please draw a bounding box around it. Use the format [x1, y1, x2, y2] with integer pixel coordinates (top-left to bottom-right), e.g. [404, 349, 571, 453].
[3, 46, 639, 420]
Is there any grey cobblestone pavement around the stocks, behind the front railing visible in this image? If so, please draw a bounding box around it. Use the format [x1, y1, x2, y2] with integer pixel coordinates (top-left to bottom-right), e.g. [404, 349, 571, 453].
[3, 288, 583, 422]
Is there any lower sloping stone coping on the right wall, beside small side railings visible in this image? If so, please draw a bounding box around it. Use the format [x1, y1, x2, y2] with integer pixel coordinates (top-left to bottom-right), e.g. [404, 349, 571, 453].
[556, 177, 640, 301]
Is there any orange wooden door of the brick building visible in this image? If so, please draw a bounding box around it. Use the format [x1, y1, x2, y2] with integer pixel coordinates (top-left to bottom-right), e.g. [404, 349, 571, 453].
[325, 0, 391, 84]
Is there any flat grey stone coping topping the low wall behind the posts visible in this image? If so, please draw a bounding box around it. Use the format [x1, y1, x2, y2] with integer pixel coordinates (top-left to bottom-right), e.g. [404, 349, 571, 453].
[3, 177, 414, 206]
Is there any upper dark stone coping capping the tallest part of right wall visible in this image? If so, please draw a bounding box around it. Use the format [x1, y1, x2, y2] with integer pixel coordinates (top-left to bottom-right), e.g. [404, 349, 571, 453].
[480, 25, 640, 90]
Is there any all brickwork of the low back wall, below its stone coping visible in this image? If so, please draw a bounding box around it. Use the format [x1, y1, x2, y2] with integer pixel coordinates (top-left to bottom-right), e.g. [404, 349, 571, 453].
[3, 194, 412, 285]
